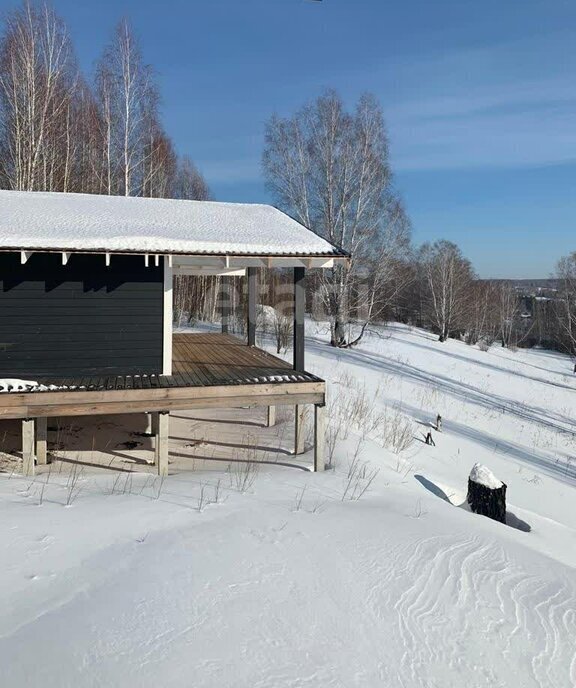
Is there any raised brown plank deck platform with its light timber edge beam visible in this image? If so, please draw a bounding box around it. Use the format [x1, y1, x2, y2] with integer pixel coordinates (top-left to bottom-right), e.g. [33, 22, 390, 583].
[0, 333, 325, 418]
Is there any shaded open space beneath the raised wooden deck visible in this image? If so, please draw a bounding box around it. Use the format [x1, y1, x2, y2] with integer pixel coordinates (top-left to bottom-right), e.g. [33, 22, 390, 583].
[0, 406, 313, 476]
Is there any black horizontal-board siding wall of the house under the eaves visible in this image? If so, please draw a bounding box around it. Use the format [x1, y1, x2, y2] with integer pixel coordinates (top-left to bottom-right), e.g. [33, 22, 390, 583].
[0, 253, 164, 378]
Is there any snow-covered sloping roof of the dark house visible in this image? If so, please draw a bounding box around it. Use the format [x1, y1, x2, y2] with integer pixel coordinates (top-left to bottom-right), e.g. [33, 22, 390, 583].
[0, 191, 346, 257]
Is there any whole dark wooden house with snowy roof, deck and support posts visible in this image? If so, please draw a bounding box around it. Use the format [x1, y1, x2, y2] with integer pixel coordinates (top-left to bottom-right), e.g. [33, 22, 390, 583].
[0, 191, 347, 475]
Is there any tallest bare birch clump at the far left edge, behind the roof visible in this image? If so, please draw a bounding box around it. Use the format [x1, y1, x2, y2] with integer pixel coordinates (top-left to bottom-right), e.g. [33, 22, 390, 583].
[0, 2, 78, 191]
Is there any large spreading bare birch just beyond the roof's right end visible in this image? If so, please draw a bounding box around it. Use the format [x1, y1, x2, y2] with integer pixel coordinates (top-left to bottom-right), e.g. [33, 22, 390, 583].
[263, 91, 410, 346]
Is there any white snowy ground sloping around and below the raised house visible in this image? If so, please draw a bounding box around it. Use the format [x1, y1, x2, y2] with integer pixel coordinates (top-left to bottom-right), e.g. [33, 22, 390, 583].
[0, 326, 576, 688]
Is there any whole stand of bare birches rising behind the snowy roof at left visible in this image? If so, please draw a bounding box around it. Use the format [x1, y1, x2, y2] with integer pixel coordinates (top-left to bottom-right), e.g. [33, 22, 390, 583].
[0, 0, 210, 207]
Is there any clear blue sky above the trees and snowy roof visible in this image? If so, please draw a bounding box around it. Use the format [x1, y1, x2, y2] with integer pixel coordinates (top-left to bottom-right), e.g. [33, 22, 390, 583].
[0, 0, 576, 277]
